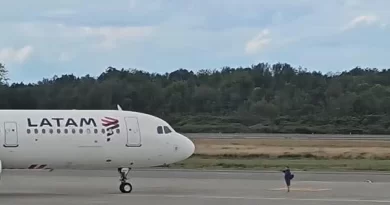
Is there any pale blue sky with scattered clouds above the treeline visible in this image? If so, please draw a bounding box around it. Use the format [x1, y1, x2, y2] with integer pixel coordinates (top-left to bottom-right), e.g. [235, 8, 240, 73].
[0, 0, 390, 83]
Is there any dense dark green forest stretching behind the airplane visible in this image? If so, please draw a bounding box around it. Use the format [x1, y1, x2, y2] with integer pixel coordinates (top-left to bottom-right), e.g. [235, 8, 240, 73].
[0, 63, 390, 134]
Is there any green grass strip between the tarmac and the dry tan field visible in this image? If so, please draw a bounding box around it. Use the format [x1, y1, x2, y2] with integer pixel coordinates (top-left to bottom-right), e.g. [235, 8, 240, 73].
[169, 156, 390, 171]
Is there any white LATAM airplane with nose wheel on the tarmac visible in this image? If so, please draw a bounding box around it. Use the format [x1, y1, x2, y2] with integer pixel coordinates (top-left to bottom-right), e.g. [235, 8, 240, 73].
[0, 105, 195, 193]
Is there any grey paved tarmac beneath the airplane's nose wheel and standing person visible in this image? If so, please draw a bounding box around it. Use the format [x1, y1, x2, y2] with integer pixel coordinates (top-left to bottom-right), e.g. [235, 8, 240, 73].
[0, 170, 390, 205]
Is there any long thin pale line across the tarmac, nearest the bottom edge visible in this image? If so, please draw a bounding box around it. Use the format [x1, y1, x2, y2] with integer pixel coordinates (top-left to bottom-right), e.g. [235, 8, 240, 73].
[123, 194, 390, 204]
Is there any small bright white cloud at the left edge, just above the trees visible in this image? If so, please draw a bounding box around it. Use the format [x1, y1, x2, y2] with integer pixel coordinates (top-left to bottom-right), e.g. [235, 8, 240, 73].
[0, 46, 34, 64]
